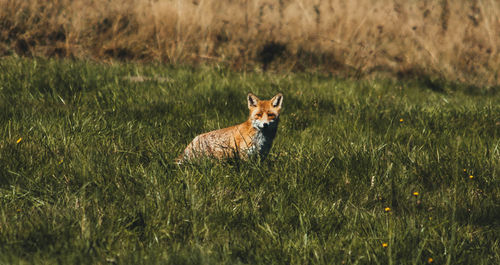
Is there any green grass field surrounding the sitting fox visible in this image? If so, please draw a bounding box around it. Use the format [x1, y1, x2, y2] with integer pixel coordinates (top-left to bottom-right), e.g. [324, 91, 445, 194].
[0, 57, 500, 264]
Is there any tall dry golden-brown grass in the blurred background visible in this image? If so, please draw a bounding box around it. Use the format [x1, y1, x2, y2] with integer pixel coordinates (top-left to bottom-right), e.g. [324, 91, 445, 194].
[0, 0, 500, 86]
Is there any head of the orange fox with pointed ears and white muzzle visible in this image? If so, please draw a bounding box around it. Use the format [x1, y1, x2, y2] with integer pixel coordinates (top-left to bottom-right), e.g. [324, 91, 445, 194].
[247, 93, 283, 130]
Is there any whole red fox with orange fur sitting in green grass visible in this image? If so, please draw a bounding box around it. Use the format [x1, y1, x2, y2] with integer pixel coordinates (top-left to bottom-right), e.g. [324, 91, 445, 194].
[176, 93, 283, 164]
